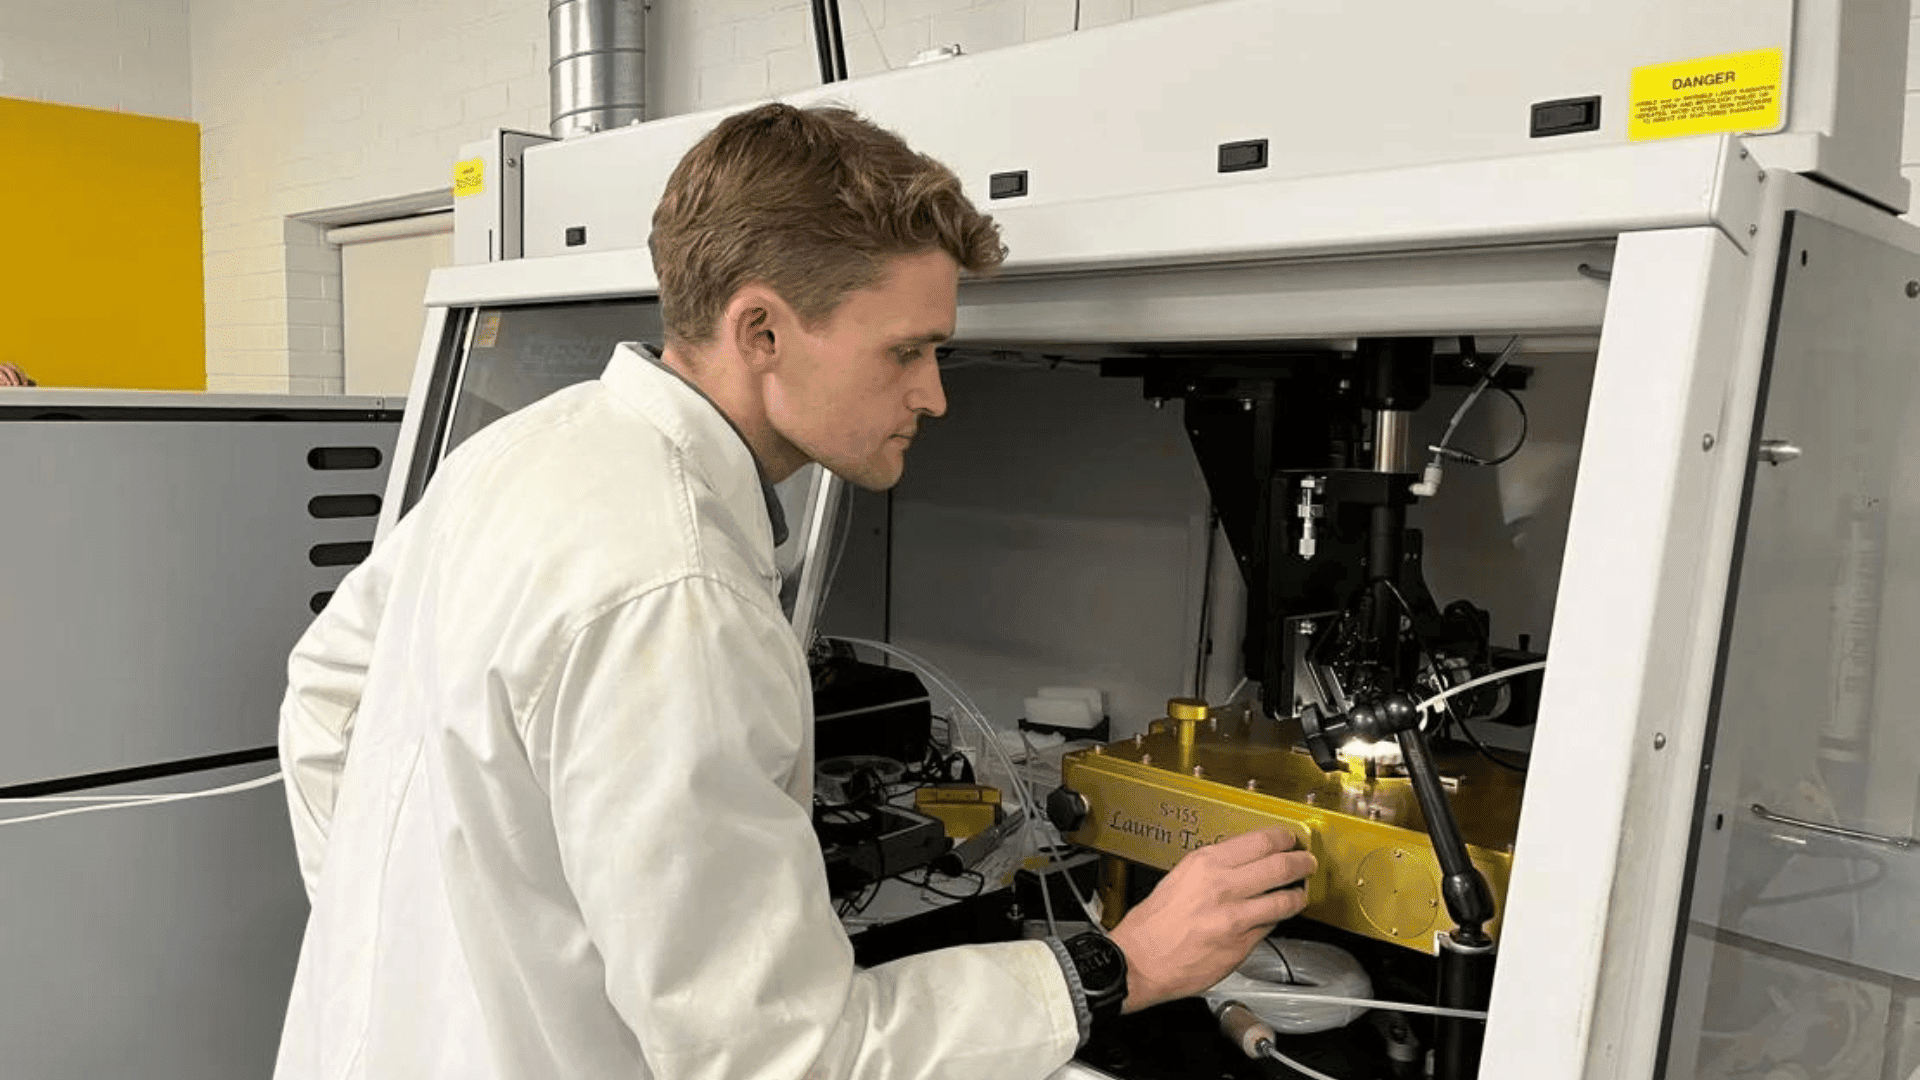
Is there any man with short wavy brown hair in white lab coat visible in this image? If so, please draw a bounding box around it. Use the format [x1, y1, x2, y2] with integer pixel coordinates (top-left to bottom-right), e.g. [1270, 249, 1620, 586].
[276, 104, 1313, 1080]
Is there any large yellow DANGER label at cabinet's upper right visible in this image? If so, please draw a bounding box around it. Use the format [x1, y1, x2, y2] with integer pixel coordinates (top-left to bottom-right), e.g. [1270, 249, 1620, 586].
[1626, 48, 1780, 142]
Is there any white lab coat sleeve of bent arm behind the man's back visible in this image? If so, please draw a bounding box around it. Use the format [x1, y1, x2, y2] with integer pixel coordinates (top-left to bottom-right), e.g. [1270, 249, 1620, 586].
[280, 532, 399, 903]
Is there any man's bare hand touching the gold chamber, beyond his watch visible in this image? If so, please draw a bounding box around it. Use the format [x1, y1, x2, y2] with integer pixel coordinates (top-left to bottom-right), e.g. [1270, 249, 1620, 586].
[1114, 824, 1315, 1013]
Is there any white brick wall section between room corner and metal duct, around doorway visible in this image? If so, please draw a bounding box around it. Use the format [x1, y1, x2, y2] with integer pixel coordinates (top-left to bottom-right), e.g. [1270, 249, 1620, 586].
[192, 0, 547, 394]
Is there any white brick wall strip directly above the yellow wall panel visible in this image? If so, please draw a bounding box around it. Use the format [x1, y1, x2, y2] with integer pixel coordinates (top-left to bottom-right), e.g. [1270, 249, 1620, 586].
[0, 0, 194, 119]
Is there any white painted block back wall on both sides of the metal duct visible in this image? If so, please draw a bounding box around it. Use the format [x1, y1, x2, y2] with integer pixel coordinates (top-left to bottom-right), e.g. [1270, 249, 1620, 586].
[190, 0, 1221, 392]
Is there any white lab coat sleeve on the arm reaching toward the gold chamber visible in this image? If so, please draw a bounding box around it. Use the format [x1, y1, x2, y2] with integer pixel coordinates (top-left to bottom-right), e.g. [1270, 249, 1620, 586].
[524, 578, 1079, 1080]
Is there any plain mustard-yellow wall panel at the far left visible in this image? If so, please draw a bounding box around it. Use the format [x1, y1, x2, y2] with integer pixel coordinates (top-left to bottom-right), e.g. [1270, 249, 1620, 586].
[0, 98, 207, 390]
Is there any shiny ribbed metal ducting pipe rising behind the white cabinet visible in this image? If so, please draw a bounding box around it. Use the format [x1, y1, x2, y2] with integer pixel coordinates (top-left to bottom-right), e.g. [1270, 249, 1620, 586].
[547, 0, 647, 138]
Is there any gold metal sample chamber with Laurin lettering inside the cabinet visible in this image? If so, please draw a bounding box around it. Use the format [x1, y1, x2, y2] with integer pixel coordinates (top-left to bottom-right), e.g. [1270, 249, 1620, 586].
[1062, 707, 1523, 953]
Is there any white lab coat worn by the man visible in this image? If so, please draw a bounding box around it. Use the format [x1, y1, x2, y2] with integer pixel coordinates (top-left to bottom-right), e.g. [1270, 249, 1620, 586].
[275, 346, 1079, 1080]
